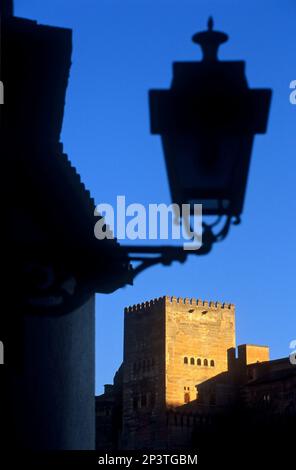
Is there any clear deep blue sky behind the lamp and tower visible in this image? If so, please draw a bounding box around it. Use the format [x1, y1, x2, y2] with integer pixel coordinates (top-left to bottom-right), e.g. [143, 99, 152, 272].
[15, 0, 296, 392]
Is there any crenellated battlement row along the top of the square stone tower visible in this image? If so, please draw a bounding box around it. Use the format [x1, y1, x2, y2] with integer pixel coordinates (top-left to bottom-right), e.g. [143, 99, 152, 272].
[124, 295, 235, 313]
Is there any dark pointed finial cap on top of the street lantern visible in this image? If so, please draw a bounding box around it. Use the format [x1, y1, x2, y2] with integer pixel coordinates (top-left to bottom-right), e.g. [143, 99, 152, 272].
[192, 16, 228, 62]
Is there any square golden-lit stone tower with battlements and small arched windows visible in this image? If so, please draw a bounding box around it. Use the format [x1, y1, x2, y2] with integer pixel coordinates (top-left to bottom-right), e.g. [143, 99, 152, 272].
[122, 296, 235, 449]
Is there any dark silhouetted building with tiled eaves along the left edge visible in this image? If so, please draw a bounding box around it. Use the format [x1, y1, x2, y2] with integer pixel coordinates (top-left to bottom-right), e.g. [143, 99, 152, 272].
[0, 0, 132, 450]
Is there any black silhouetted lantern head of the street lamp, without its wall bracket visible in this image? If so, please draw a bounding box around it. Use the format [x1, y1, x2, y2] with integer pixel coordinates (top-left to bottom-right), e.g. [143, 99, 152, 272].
[150, 18, 271, 238]
